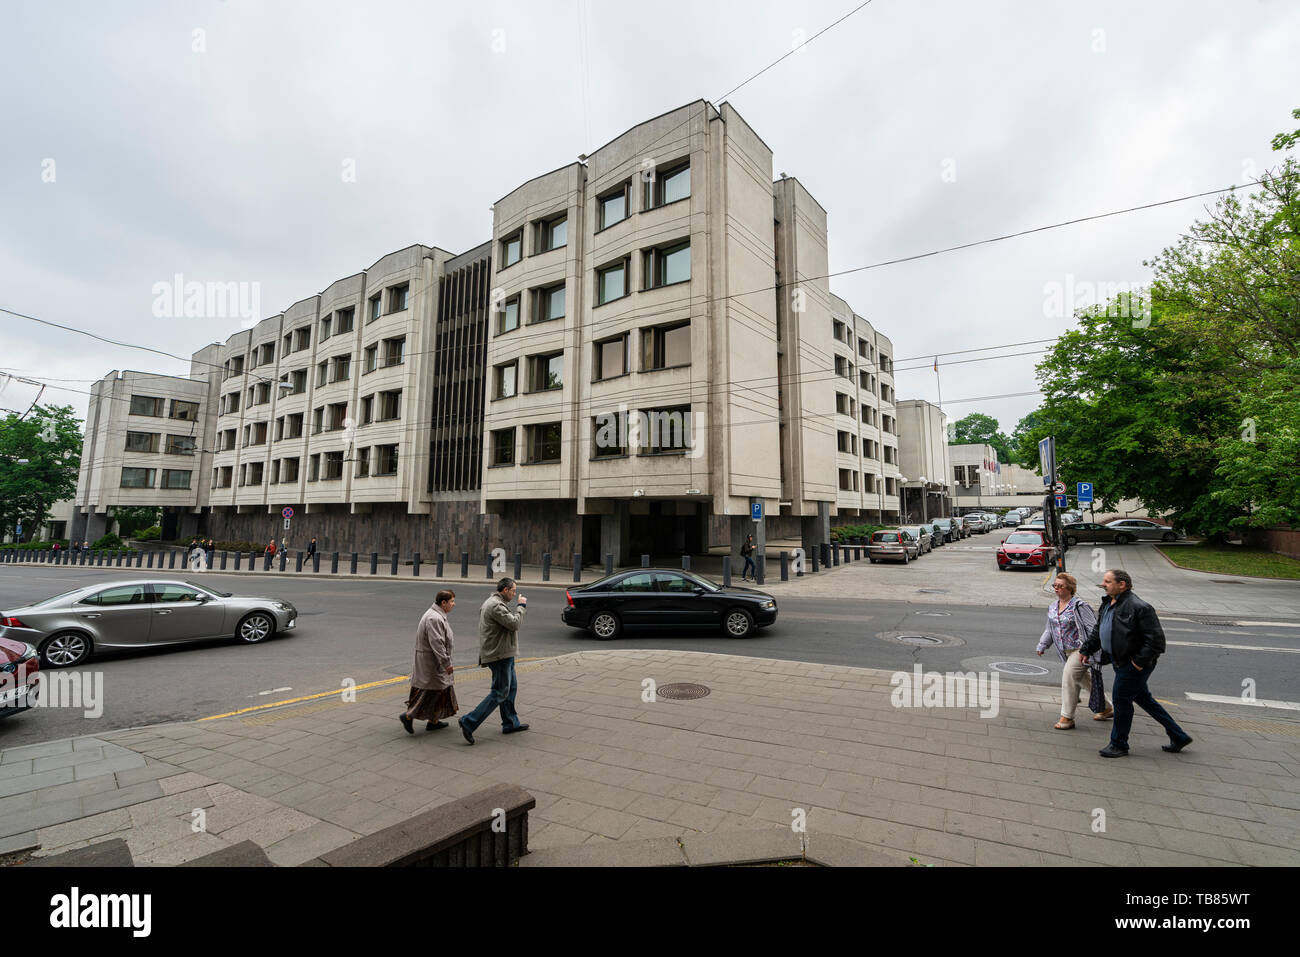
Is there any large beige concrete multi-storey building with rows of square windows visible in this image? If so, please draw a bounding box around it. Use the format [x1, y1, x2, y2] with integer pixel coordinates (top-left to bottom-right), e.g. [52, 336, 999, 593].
[70, 100, 925, 564]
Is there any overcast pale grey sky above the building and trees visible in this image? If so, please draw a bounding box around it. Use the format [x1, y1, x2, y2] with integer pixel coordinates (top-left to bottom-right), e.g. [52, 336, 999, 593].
[0, 0, 1300, 432]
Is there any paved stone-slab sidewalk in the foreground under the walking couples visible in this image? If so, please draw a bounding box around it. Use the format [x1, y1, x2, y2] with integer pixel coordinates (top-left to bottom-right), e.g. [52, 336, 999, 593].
[0, 650, 1300, 866]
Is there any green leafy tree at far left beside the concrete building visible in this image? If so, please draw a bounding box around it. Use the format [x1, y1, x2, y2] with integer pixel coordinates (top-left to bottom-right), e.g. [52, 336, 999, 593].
[0, 406, 82, 537]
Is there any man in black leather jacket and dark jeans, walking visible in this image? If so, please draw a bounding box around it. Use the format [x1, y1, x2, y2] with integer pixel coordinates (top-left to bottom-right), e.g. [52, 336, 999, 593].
[1079, 568, 1192, 758]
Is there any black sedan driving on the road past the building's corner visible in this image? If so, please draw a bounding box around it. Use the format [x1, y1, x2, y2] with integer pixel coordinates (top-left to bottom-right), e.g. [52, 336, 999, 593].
[560, 568, 776, 641]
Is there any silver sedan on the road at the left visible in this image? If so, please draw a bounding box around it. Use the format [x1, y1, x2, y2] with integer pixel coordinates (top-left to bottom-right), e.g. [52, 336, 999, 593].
[0, 580, 298, 667]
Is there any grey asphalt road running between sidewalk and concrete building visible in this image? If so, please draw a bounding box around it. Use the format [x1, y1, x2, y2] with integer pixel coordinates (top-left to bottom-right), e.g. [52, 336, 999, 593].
[0, 561, 1300, 748]
